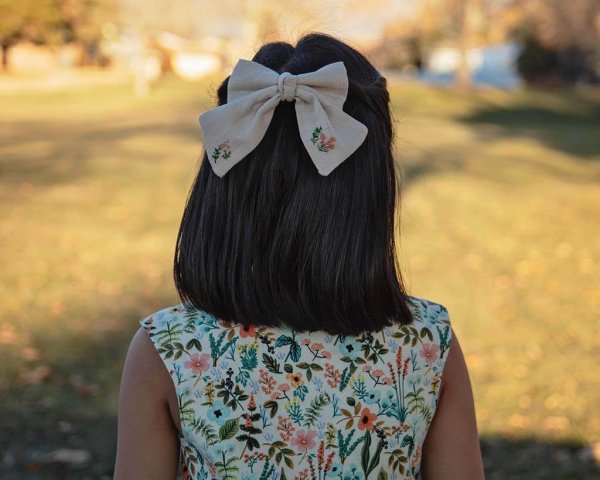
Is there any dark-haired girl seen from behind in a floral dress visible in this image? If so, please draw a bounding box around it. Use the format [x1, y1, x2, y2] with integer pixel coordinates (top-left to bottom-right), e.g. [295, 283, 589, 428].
[115, 34, 484, 480]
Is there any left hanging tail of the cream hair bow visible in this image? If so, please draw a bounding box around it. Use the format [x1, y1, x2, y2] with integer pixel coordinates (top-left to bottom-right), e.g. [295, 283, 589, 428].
[199, 90, 279, 177]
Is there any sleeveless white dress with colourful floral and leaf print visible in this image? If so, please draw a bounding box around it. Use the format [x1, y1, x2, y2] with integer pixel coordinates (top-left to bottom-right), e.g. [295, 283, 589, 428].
[141, 296, 451, 480]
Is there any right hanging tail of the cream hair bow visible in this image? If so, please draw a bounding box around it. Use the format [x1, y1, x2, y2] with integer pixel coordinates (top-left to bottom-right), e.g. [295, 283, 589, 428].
[296, 97, 368, 176]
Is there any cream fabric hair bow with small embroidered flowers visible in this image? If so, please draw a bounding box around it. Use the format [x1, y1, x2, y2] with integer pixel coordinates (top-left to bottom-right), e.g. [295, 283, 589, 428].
[200, 60, 368, 177]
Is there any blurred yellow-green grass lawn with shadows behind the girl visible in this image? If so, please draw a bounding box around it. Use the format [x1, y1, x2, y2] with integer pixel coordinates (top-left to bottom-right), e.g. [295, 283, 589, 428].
[0, 73, 600, 480]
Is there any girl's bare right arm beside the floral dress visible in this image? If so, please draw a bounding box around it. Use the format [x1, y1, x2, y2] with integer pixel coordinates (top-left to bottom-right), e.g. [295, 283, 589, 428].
[422, 329, 485, 480]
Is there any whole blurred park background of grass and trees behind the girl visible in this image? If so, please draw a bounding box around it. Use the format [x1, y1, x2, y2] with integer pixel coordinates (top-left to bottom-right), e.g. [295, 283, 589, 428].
[0, 0, 600, 480]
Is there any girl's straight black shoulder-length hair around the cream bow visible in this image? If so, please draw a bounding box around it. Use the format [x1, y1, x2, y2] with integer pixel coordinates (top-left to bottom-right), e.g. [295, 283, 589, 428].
[174, 33, 413, 335]
